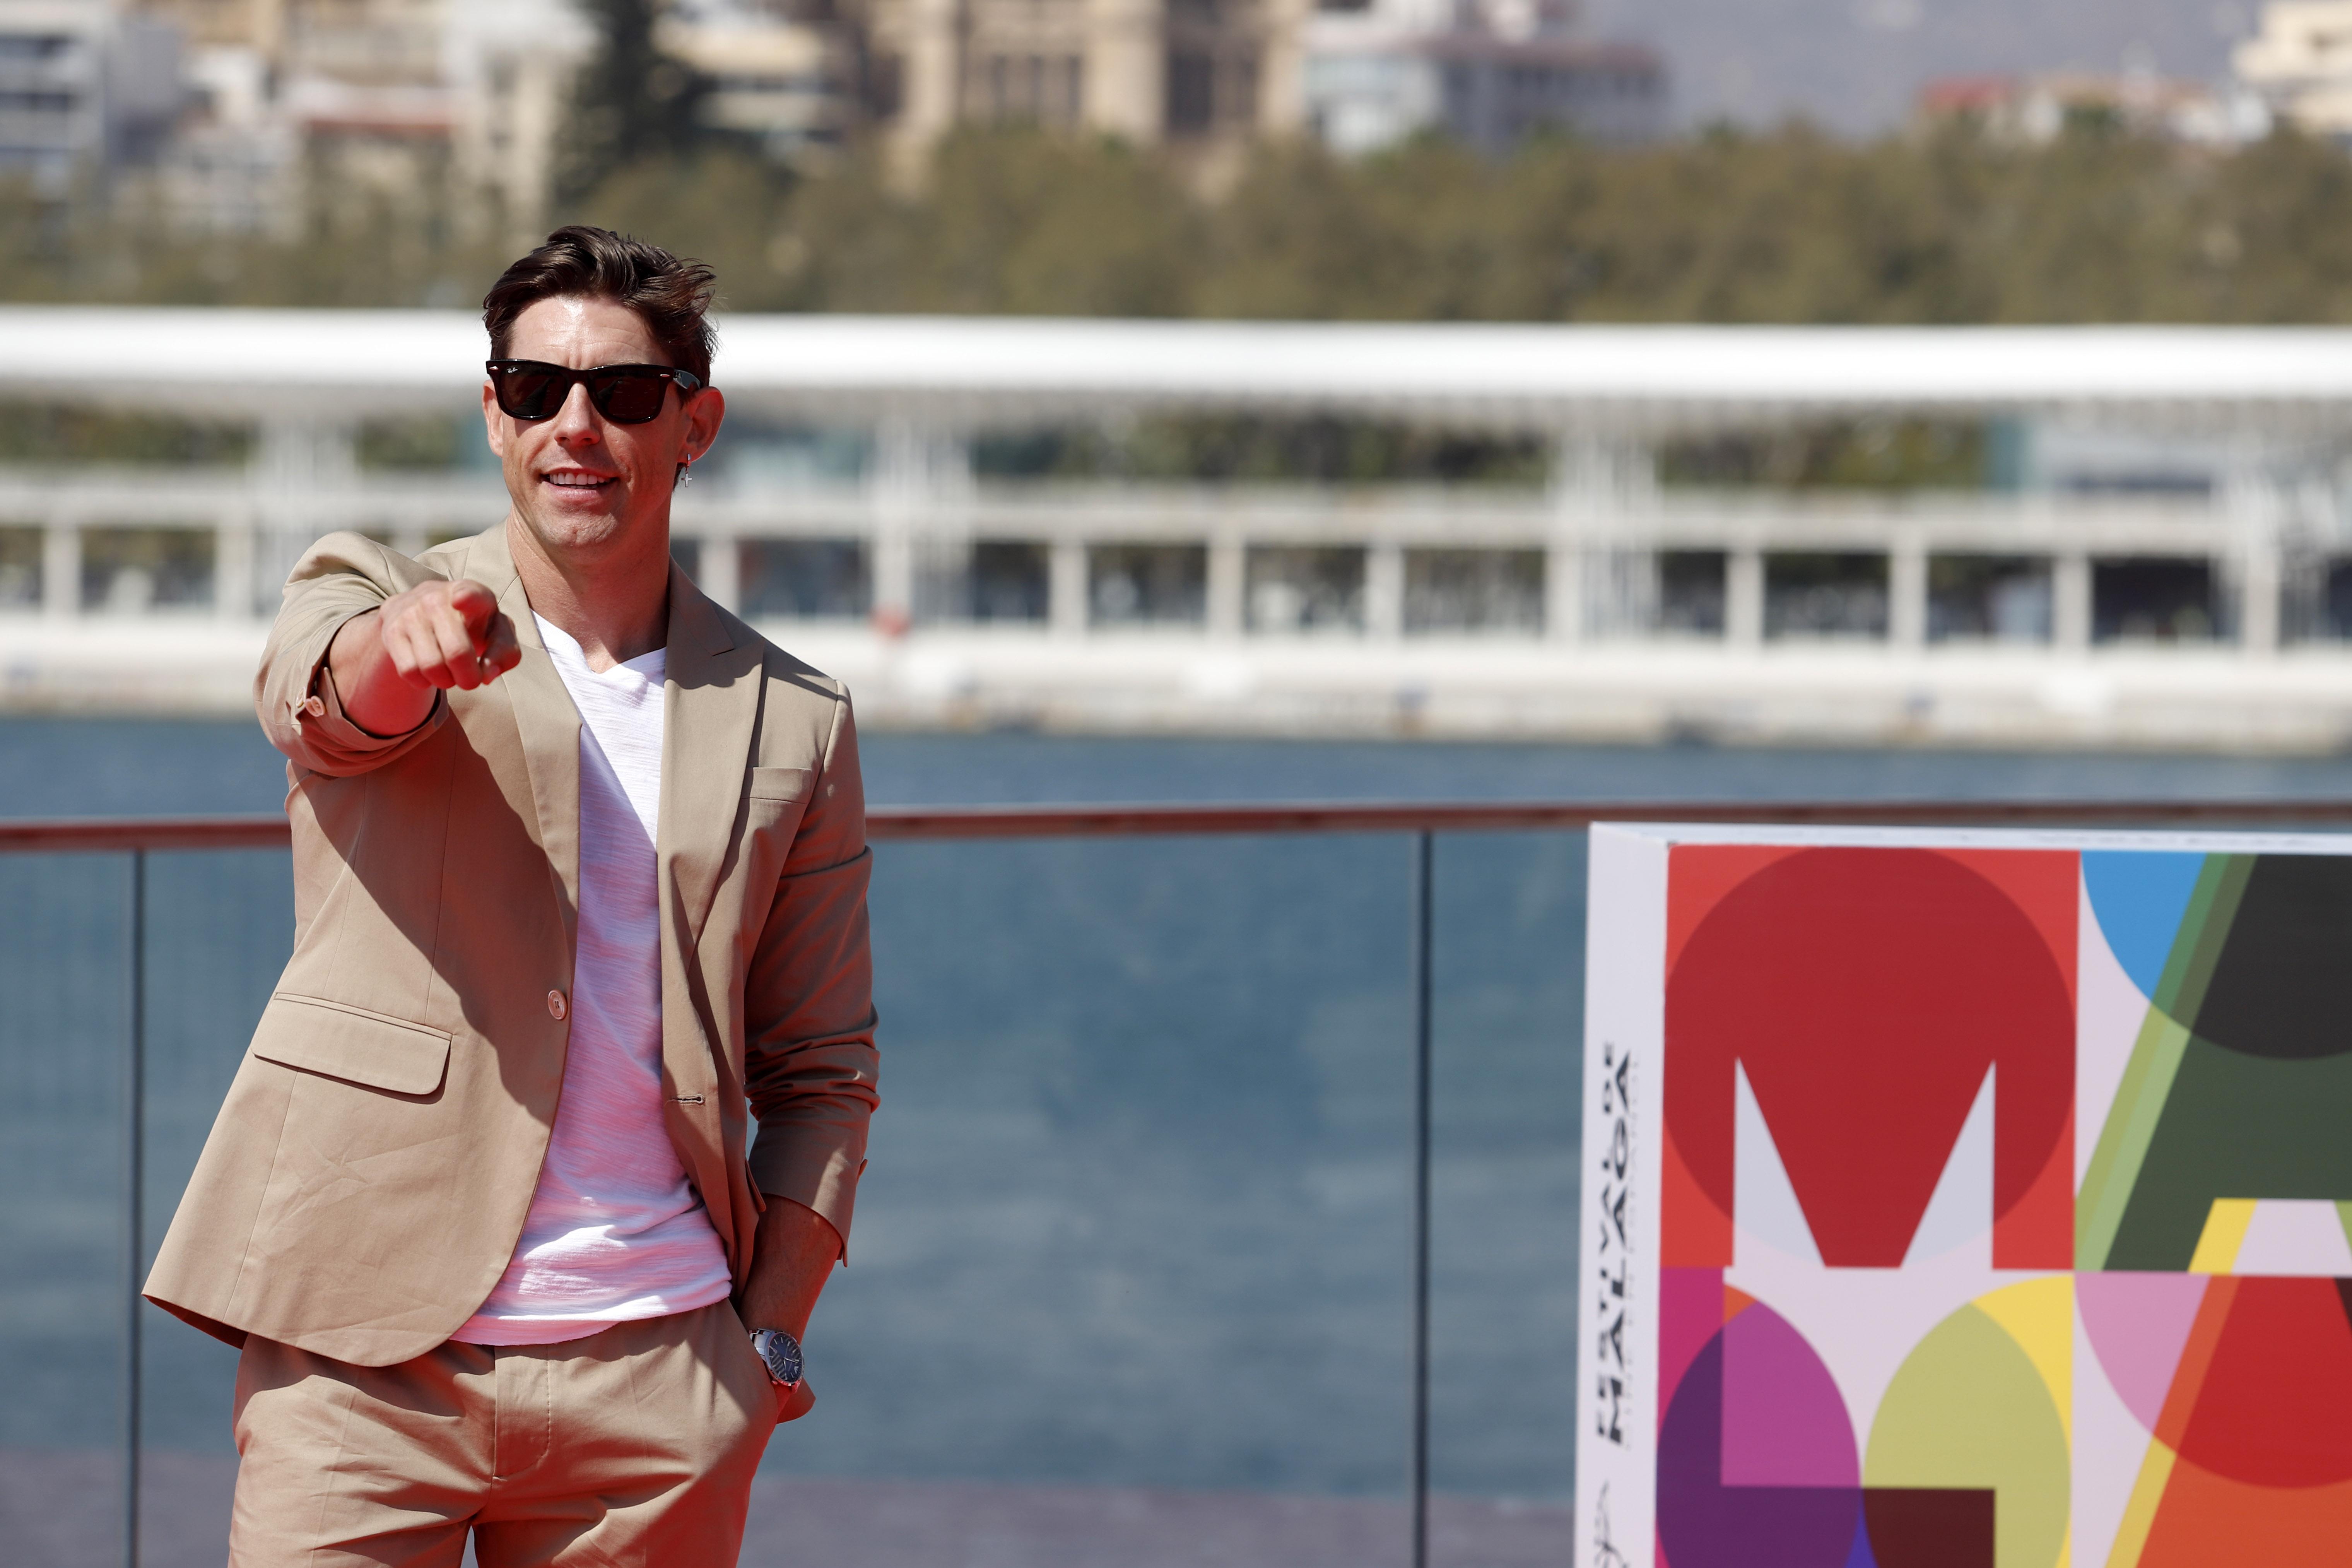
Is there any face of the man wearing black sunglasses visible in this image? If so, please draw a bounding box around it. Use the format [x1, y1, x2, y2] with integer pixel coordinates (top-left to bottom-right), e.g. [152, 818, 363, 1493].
[482, 299, 725, 557]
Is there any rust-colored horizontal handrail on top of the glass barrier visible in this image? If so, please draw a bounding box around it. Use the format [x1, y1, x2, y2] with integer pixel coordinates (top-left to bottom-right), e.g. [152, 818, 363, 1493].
[0, 797, 2352, 853]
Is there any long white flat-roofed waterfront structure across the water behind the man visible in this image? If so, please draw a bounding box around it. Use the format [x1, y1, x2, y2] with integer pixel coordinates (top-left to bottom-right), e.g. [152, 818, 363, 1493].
[0, 308, 2352, 750]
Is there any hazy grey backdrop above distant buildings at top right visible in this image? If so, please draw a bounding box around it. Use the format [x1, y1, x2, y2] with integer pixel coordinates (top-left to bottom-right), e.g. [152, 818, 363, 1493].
[1585, 0, 2258, 136]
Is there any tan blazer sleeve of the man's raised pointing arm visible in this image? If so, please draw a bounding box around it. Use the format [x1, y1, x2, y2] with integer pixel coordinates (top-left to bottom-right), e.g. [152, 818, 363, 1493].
[254, 533, 449, 776]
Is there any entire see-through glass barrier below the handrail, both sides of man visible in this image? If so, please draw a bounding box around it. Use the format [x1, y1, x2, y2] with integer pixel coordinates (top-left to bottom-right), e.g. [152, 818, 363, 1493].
[0, 834, 1608, 1568]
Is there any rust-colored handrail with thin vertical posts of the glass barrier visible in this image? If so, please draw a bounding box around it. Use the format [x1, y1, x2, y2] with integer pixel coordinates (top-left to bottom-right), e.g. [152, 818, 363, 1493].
[18, 799, 2352, 1568]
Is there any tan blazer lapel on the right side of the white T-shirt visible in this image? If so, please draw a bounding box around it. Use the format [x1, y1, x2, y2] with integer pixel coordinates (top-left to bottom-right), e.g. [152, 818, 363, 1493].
[656, 564, 764, 952]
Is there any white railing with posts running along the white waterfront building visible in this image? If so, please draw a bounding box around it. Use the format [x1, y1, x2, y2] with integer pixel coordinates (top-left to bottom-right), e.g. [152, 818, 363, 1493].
[0, 484, 2296, 649]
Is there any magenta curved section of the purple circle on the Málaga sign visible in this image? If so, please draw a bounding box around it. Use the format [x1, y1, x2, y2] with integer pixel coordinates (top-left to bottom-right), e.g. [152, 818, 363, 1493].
[1724, 1302, 1860, 1486]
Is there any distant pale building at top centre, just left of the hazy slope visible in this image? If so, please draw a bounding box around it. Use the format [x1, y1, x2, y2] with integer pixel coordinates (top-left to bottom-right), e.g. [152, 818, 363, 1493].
[1303, 0, 1665, 155]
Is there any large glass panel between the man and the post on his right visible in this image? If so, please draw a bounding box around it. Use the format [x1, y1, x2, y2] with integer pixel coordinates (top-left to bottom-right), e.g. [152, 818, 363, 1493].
[745, 834, 1411, 1568]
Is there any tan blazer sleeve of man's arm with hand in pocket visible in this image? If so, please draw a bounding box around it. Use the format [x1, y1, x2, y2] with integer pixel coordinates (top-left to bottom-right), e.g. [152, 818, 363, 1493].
[743, 691, 880, 1253]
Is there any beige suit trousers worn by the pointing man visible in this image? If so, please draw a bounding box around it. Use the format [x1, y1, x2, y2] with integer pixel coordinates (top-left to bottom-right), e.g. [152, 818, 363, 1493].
[228, 1302, 778, 1568]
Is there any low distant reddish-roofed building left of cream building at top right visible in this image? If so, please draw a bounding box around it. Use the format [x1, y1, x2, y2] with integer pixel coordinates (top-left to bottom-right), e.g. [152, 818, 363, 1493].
[1919, 70, 2270, 146]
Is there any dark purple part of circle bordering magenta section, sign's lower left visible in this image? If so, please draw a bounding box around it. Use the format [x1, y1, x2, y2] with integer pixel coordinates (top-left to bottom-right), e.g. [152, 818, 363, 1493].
[1658, 1335, 1863, 1568]
